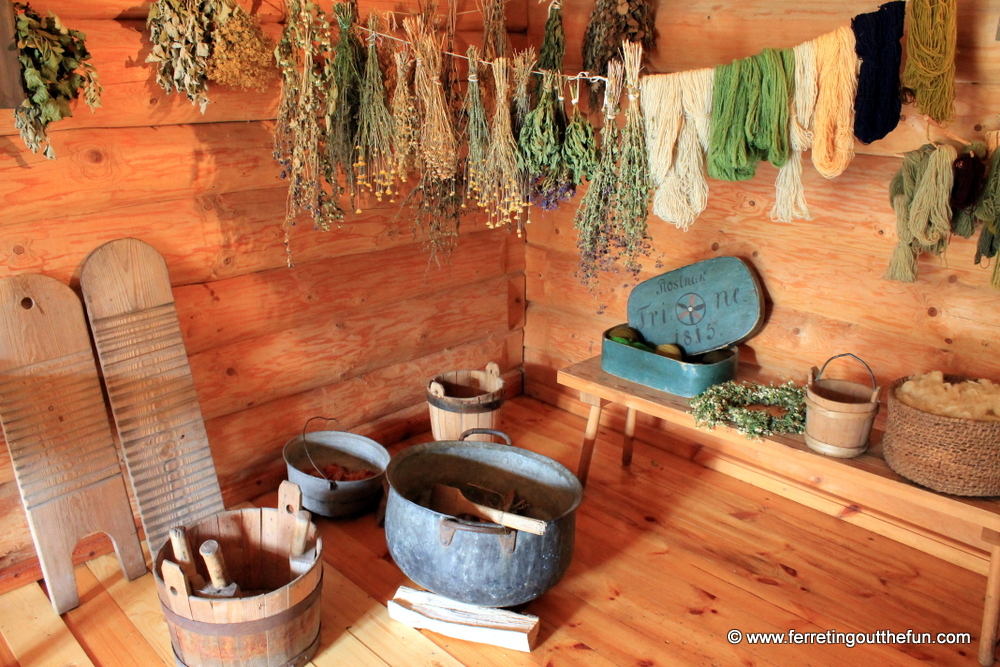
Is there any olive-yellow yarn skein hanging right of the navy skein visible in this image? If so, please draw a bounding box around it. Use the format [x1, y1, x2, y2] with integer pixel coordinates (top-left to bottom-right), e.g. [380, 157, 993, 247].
[903, 0, 958, 123]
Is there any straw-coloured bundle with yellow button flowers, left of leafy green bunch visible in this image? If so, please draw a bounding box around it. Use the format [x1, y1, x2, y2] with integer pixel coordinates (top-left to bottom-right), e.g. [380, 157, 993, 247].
[479, 58, 524, 234]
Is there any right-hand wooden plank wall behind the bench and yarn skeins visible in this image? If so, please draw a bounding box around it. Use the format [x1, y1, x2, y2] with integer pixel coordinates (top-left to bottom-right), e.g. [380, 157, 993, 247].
[525, 0, 1000, 448]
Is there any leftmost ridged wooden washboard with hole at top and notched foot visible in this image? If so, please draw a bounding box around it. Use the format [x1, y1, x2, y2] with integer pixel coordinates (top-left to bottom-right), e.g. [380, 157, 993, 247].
[0, 275, 146, 614]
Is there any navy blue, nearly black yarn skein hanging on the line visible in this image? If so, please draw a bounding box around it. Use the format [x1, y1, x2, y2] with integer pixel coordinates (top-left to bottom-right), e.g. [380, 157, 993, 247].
[851, 0, 906, 144]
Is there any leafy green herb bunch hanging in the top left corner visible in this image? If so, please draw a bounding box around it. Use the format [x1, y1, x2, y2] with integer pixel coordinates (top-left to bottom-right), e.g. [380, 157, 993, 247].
[14, 3, 101, 160]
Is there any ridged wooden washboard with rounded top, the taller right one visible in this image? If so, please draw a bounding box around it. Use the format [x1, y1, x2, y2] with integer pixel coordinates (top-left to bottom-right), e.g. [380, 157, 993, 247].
[80, 239, 225, 554]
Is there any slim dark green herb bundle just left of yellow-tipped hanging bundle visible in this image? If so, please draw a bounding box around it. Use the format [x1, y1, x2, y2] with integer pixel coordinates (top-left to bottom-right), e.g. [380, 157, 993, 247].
[328, 2, 364, 213]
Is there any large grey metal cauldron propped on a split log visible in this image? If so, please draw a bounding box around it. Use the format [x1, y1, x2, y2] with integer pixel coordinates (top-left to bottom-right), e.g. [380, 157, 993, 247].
[385, 429, 583, 607]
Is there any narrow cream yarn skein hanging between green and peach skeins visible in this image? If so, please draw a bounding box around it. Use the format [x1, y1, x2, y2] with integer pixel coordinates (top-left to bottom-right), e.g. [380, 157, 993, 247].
[771, 42, 818, 222]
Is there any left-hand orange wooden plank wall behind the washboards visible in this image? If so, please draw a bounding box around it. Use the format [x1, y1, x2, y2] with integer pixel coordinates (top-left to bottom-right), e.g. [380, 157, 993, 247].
[0, 0, 527, 591]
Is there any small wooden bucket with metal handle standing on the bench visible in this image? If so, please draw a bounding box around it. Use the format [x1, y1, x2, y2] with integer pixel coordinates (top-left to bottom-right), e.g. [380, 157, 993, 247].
[805, 353, 880, 458]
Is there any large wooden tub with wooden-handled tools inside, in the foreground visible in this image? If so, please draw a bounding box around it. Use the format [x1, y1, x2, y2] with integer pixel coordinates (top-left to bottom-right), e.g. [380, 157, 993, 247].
[153, 482, 323, 667]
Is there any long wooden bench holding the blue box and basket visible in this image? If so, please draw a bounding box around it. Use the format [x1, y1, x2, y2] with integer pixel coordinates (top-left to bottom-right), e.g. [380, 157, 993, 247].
[558, 356, 1000, 667]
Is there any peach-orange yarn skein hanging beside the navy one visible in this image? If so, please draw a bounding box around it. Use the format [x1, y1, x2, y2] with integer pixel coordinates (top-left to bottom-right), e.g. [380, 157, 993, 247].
[812, 26, 858, 178]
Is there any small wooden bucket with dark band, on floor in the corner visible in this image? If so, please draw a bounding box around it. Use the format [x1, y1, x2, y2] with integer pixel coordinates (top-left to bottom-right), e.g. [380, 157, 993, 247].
[427, 362, 503, 442]
